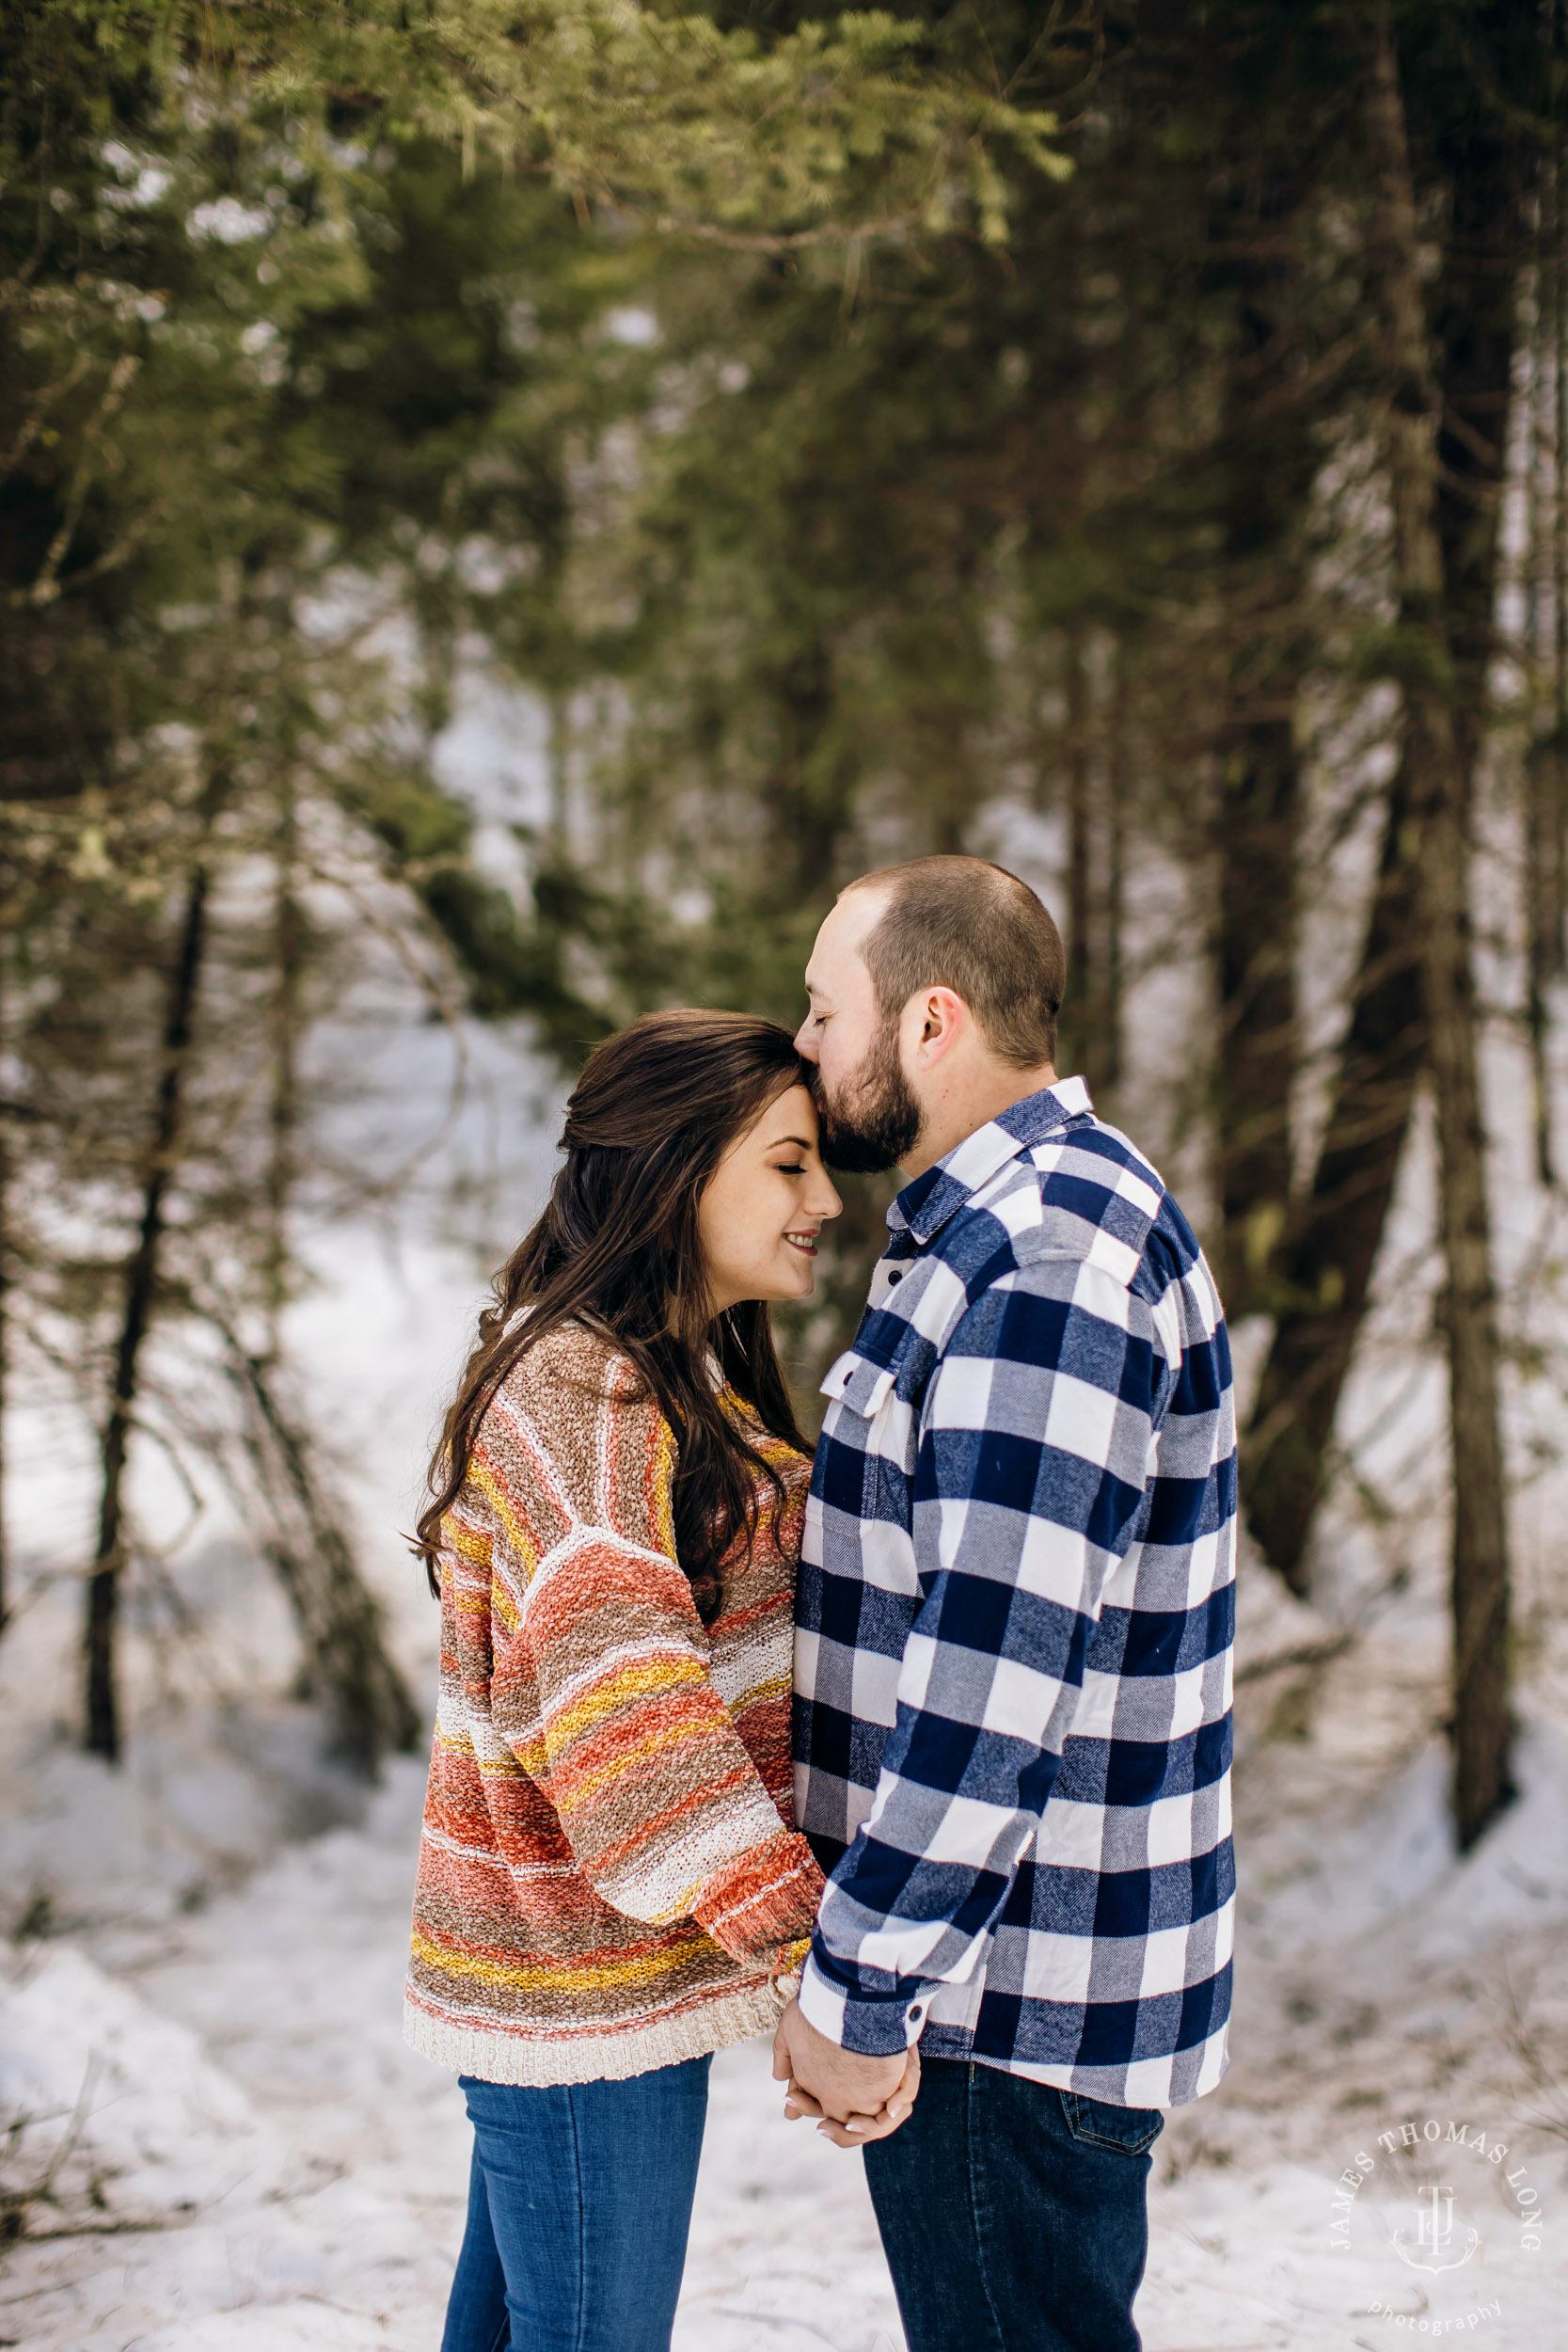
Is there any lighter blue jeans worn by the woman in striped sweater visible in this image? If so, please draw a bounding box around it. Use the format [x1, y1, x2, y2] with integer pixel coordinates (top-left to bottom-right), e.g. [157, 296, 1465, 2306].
[442, 2058, 712, 2352]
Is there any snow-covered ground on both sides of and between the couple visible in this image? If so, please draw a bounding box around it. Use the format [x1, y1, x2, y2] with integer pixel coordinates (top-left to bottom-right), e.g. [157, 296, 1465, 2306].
[0, 1663, 1568, 2352]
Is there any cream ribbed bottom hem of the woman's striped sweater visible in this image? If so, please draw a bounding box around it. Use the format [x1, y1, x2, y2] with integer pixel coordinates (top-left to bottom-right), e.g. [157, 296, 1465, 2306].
[402, 1983, 787, 2089]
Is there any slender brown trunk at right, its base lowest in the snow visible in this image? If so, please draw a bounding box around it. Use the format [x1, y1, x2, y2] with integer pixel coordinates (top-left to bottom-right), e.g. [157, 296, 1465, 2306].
[1366, 12, 1512, 1847]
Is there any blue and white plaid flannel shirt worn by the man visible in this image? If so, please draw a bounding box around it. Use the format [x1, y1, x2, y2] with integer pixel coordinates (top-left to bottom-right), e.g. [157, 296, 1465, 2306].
[795, 1077, 1237, 2107]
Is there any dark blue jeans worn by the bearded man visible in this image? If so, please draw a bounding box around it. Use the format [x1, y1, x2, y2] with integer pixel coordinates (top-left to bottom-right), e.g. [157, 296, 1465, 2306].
[865, 2058, 1164, 2352]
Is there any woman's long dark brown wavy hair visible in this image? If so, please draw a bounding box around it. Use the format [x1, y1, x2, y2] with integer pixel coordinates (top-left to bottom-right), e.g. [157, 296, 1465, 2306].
[416, 1011, 811, 1618]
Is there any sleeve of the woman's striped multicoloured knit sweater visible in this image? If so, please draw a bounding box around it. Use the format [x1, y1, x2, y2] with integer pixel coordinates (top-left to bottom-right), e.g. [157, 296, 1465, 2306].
[494, 1374, 823, 1974]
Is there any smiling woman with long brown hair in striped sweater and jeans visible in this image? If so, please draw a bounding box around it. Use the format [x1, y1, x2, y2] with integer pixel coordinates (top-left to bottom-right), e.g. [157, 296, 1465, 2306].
[406, 1011, 839, 2352]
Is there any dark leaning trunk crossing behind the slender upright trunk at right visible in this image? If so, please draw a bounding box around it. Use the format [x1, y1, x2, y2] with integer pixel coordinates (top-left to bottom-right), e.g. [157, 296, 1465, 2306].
[1242, 13, 1521, 1593]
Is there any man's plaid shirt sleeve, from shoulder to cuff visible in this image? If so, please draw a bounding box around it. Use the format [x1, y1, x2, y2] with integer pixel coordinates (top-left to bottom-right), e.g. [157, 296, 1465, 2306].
[800, 1261, 1171, 2056]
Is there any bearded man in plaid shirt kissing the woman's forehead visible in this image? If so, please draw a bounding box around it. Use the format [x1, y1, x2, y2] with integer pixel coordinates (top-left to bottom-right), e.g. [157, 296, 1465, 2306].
[776, 859, 1237, 2352]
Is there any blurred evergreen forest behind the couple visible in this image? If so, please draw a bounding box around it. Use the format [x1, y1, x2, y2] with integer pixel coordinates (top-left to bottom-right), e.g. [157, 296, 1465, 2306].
[0, 0, 1568, 2343]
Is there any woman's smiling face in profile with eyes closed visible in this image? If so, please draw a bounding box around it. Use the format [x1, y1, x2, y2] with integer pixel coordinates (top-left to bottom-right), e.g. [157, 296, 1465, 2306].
[696, 1087, 844, 1315]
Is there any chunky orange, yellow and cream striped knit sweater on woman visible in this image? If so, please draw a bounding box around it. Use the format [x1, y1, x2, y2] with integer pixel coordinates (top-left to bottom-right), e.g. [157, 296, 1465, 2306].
[404, 1325, 823, 2084]
